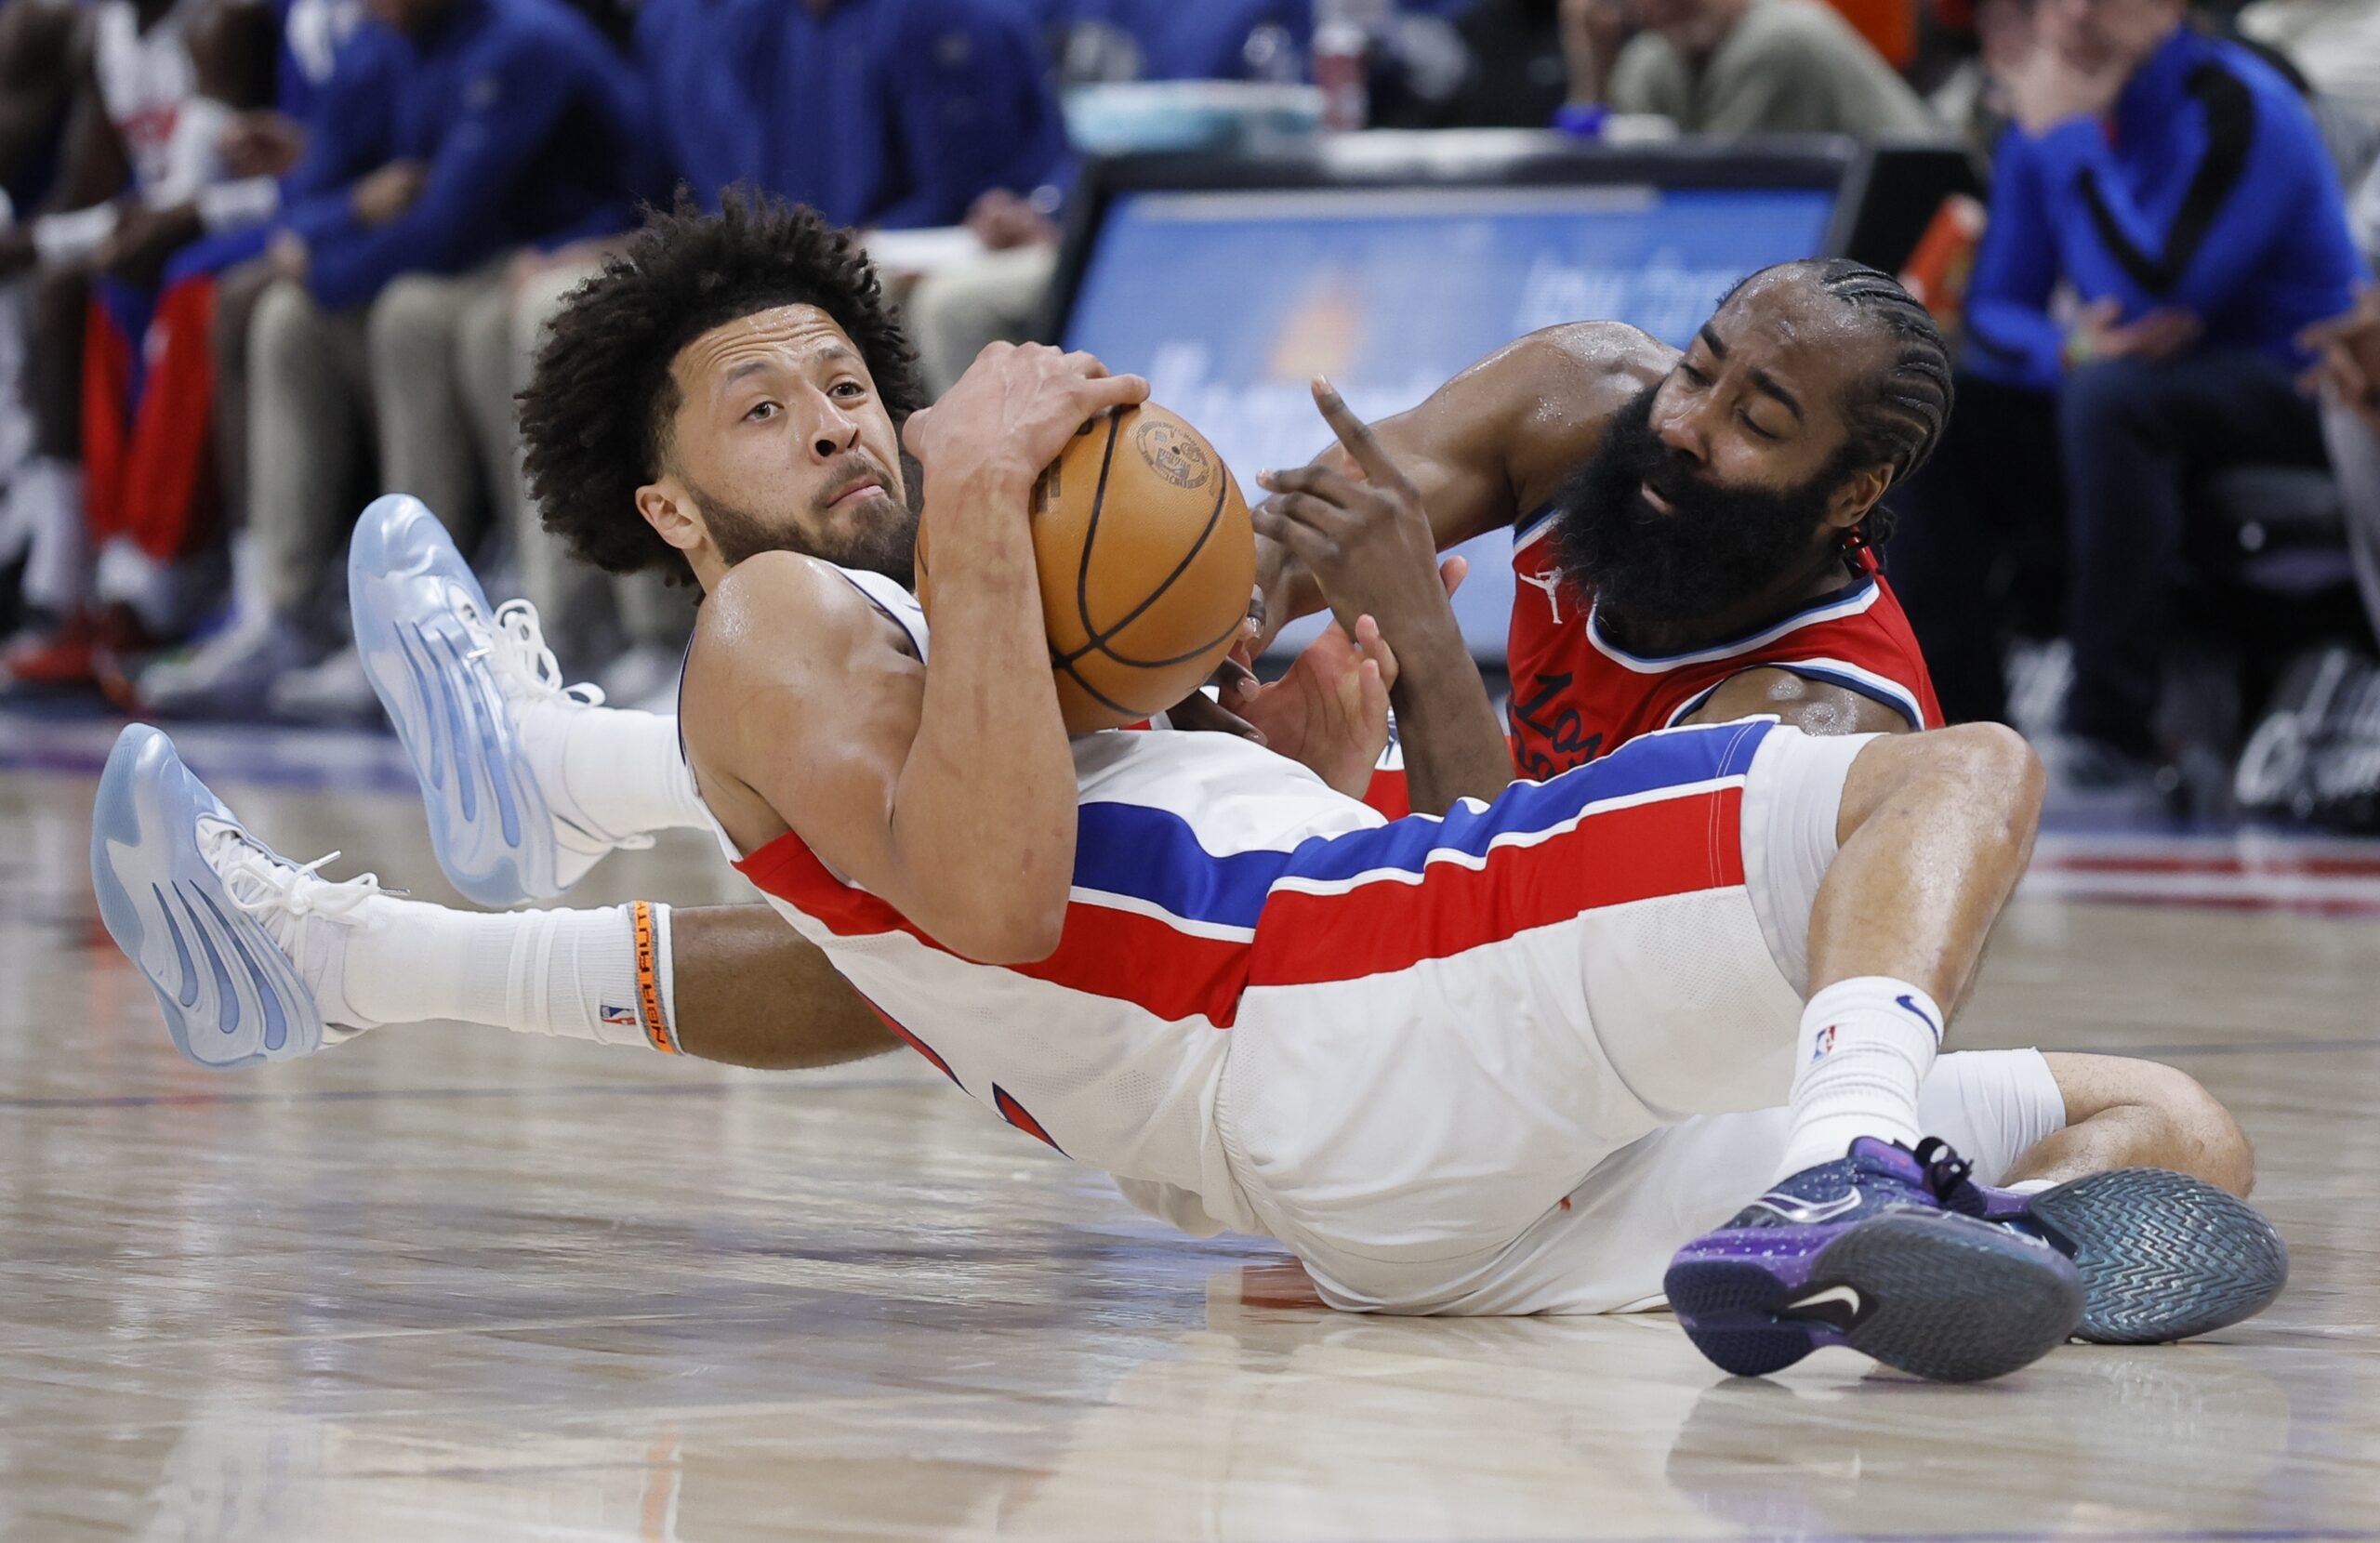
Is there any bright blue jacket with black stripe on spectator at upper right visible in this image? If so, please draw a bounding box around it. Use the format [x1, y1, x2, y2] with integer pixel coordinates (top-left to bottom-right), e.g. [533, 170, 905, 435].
[1966, 29, 2366, 390]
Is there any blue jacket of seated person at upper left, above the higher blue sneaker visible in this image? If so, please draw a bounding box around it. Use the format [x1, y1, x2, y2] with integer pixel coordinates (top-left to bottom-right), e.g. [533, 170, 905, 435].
[284, 0, 662, 307]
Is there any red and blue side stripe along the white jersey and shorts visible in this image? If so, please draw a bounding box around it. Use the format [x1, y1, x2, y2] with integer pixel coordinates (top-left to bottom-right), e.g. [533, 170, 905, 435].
[738, 721, 1773, 1029]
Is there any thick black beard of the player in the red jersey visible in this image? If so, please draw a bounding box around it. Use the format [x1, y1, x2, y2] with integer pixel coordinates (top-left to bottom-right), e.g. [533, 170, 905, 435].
[1552, 386, 1849, 624]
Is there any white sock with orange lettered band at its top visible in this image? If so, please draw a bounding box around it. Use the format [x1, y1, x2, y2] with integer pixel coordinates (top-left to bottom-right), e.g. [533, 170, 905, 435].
[324, 895, 679, 1055]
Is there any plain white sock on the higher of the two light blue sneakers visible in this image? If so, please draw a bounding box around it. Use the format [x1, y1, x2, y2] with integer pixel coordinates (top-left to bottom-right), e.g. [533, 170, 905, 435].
[536, 703, 711, 843]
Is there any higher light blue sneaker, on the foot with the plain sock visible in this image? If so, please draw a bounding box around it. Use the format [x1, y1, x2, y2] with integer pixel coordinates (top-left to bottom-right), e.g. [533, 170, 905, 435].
[348, 493, 564, 904]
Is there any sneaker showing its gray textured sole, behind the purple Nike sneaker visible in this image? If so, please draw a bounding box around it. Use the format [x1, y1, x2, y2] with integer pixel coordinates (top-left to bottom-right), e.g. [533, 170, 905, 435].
[1942, 1169, 2290, 1345]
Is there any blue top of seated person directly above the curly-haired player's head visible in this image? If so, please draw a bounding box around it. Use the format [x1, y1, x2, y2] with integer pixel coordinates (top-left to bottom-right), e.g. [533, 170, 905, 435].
[761, 0, 1066, 229]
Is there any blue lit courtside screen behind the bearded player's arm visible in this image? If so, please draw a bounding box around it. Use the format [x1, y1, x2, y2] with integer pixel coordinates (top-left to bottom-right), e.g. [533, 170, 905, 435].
[1064, 181, 1835, 660]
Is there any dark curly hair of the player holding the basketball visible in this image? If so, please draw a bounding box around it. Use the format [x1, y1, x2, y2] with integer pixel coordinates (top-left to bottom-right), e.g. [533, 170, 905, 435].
[519, 186, 926, 579]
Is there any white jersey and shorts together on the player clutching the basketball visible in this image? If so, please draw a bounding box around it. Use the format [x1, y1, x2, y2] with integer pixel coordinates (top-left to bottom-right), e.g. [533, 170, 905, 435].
[694, 560, 2064, 1312]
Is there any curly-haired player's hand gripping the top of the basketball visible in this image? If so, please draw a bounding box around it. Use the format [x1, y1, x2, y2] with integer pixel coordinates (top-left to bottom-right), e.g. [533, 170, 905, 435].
[902, 343, 1149, 481]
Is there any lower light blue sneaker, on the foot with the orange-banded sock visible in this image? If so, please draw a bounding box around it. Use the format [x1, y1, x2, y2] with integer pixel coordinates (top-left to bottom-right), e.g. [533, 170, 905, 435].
[90, 724, 324, 1067]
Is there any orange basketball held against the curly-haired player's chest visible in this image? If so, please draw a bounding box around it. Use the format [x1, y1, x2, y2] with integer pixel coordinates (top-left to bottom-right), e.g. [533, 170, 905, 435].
[917, 402, 1257, 733]
